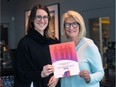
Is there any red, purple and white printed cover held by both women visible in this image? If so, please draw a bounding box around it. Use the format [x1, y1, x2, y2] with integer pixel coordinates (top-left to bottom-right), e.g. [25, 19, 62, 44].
[49, 42, 79, 78]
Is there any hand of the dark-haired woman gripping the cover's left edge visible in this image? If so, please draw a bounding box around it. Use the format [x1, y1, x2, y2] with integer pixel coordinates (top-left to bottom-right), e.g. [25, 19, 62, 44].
[41, 64, 54, 77]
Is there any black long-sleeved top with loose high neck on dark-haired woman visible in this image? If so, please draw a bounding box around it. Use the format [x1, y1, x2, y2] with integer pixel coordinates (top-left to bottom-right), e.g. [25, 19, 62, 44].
[15, 30, 60, 87]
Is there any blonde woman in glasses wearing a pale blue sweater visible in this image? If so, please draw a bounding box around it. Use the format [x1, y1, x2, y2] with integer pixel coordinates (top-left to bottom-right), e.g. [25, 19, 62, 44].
[61, 10, 104, 87]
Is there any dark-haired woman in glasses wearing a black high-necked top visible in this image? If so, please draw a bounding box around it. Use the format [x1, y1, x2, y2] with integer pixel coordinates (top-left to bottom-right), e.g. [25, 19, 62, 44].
[15, 4, 60, 87]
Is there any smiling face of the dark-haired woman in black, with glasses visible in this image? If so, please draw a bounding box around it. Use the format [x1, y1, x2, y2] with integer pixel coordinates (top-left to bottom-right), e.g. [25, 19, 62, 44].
[34, 9, 48, 35]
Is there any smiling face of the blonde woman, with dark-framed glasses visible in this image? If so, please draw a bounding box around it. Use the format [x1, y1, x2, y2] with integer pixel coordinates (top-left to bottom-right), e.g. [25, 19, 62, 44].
[64, 17, 79, 38]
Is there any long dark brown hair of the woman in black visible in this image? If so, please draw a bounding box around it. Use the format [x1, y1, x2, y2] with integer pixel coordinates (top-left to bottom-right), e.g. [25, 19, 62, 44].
[27, 4, 51, 37]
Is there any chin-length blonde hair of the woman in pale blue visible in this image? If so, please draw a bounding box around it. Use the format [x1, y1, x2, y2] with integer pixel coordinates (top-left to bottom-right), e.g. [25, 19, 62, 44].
[62, 10, 86, 39]
